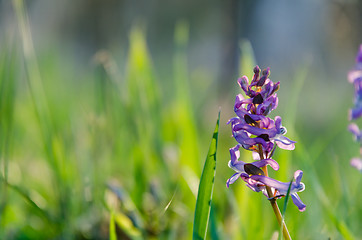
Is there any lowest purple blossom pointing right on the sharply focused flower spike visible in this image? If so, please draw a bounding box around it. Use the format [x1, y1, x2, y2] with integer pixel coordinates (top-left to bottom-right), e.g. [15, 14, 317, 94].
[250, 170, 306, 212]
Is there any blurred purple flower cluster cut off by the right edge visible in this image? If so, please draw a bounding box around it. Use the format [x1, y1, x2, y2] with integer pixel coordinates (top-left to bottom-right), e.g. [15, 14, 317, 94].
[348, 44, 362, 172]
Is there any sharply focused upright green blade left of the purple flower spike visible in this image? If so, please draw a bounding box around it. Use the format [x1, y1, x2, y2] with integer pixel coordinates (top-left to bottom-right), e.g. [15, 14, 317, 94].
[192, 112, 220, 239]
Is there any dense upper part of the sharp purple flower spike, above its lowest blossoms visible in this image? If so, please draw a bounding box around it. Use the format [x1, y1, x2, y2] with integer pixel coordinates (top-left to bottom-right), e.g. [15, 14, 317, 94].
[228, 66, 295, 154]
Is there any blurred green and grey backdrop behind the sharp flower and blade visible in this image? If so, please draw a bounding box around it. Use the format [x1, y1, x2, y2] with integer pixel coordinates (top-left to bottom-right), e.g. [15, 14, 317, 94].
[0, 0, 362, 239]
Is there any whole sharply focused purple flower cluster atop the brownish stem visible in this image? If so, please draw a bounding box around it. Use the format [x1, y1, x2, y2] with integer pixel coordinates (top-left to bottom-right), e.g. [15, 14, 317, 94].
[226, 66, 306, 211]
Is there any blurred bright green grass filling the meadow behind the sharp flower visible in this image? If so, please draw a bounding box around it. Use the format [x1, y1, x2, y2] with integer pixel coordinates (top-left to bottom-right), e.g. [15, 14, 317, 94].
[0, 1, 362, 239]
